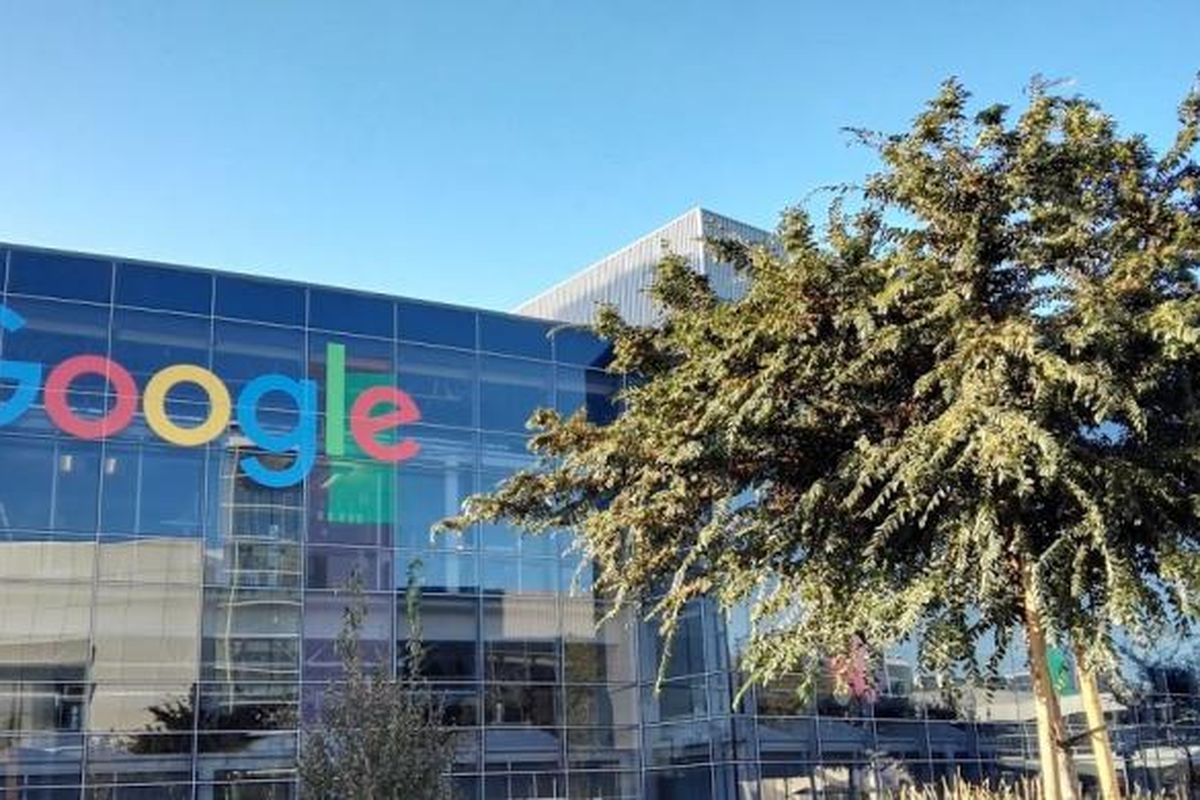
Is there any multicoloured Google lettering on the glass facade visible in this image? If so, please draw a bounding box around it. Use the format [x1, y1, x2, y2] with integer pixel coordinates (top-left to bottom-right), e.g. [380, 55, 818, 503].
[0, 305, 421, 488]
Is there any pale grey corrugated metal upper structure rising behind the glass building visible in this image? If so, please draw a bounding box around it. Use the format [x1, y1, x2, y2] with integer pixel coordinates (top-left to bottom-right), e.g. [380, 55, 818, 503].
[515, 207, 770, 325]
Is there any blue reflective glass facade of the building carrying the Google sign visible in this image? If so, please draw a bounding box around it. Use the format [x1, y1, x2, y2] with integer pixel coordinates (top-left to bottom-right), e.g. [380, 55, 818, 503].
[0, 247, 1200, 800]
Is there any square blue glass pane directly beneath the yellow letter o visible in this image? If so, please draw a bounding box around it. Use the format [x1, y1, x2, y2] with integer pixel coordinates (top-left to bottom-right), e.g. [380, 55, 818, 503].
[102, 444, 205, 536]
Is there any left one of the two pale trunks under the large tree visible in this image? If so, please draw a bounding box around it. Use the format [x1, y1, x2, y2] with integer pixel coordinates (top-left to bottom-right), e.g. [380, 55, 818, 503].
[1021, 565, 1075, 800]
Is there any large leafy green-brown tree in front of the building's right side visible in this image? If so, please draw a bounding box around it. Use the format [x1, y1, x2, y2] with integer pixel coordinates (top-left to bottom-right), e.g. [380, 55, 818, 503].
[446, 80, 1200, 800]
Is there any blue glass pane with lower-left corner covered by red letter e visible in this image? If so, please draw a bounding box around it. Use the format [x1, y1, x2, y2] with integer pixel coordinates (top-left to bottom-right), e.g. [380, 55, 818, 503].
[397, 344, 479, 428]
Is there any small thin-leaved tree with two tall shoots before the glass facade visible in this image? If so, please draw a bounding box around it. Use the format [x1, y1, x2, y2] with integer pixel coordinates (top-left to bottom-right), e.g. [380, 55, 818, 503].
[299, 570, 455, 800]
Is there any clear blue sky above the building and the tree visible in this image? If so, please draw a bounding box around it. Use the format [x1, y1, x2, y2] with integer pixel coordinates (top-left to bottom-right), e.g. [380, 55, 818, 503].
[0, 0, 1200, 308]
